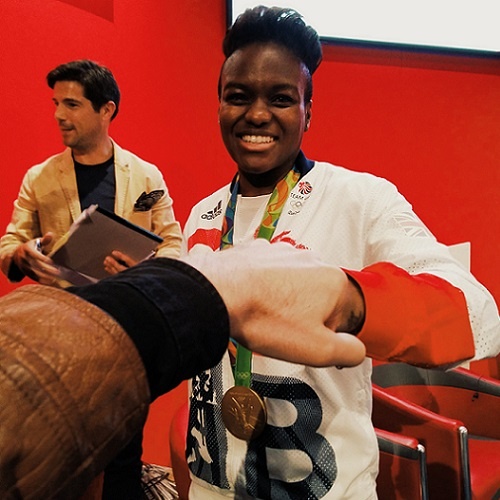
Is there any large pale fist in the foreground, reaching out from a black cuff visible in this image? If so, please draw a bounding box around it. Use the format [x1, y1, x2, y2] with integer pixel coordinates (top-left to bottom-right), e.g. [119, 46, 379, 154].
[183, 239, 365, 366]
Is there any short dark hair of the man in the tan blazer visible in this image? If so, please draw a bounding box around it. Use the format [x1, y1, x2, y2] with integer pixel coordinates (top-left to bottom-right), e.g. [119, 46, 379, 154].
[47, 59, 120, 119]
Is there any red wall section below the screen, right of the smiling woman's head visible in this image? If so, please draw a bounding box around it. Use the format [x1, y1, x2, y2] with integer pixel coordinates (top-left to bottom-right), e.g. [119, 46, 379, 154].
[306, 46, 500, 303]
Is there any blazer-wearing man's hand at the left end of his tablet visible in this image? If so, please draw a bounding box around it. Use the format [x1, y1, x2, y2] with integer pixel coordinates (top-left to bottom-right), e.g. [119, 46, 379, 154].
[12, 233, 59, 285]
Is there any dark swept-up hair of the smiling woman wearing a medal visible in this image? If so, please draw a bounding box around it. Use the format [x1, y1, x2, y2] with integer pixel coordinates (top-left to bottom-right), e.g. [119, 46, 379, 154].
[222, 5, 323, 102]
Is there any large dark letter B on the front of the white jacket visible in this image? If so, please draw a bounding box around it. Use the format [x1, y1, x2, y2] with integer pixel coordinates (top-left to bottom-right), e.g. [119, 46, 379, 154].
[236, 376, 337, 500]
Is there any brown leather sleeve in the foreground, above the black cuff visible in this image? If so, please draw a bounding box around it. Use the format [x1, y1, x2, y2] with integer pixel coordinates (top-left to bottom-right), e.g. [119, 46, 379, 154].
[0, 285, 150, 499]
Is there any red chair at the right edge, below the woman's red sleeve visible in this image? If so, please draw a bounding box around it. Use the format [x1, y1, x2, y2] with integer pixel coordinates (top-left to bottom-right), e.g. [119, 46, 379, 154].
[372, 363, 500, 499]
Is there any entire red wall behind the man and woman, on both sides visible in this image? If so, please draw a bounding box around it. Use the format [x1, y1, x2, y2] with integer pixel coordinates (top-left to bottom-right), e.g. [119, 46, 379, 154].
[0, 0, 500, 463]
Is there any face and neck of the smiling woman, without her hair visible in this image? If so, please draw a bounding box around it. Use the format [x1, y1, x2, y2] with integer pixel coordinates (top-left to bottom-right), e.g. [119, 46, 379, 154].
[219, 43, 311, 196]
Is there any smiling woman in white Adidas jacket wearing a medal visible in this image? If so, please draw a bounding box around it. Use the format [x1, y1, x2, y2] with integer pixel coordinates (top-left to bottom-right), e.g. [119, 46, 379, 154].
[181, 6, 500, 499]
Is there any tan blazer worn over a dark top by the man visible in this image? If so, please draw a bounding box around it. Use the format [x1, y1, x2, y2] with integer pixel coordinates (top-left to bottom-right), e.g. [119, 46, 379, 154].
[0, 143, 182, 280]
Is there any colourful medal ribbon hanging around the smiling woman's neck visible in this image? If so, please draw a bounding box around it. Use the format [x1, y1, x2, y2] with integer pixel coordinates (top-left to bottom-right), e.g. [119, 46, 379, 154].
[220, 165, 300, 387]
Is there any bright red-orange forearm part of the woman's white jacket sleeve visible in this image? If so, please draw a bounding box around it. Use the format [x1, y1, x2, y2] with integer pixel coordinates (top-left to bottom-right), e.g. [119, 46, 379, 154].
[346, 262, 474, 367]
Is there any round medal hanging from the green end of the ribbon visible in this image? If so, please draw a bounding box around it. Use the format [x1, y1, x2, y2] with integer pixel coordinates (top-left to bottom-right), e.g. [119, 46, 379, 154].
[222, 385, 267, 441]
